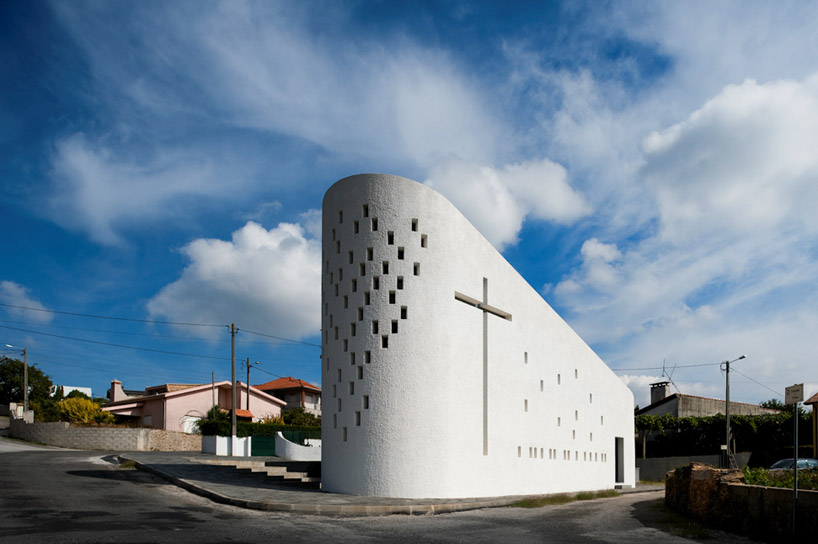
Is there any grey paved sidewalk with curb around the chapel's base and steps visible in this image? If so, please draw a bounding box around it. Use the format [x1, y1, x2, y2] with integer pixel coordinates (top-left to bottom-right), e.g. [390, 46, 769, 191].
[119, 452, 664, 517]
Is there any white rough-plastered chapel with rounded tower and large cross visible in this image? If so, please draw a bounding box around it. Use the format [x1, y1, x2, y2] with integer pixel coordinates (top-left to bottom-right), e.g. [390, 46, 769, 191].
[321, 174, 635, 498]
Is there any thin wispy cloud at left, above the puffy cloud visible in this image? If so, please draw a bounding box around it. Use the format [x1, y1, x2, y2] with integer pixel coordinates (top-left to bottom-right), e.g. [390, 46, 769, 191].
[48, 134, 249, 245]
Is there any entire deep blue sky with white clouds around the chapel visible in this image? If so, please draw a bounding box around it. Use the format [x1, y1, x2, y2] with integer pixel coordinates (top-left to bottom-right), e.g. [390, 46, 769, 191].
[0, 1, 818, 406]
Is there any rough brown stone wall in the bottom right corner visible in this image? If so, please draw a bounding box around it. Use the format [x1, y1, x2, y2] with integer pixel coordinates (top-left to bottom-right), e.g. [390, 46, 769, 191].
[665, 463, 818, 542]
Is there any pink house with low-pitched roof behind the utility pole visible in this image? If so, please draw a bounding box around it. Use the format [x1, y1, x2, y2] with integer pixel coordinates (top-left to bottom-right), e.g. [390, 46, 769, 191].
[102, 380, 286, 433]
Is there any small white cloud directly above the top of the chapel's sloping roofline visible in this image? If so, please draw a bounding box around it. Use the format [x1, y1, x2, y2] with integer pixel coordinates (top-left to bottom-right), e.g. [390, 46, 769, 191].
[425, 159, 591, 250]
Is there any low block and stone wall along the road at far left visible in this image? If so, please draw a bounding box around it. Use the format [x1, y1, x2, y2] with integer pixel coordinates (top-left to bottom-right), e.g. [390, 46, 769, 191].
[9, 419, 202, 451]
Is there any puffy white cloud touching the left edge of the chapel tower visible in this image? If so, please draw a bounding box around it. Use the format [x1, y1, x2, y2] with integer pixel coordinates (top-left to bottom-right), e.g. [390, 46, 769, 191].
[148, 222, 321, 339]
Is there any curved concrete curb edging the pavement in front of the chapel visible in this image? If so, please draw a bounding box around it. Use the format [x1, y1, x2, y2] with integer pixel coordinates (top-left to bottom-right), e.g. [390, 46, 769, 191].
[118, 455, 519, 517]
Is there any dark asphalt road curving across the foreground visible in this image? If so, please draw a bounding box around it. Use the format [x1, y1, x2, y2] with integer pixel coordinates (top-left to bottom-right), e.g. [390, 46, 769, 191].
[0, 438, 748, 544]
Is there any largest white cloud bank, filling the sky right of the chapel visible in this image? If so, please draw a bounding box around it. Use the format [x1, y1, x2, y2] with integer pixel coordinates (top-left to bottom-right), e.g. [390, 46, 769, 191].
[553, 71, 818, 402]
